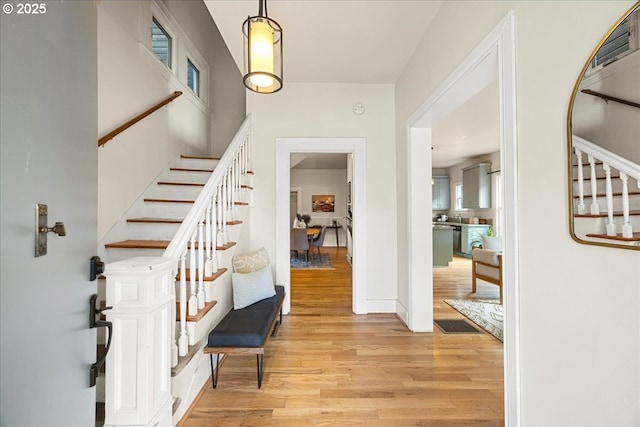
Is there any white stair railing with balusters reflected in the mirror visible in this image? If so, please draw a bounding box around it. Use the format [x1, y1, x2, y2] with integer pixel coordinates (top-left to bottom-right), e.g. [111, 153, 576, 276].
[572, 135, 640, 238]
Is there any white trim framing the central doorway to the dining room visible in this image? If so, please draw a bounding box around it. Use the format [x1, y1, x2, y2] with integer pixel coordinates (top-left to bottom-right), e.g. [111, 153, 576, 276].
[275, 138, 368, 314]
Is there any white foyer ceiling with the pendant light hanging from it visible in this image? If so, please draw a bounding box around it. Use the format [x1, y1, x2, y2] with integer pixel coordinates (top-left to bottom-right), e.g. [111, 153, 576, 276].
[205, 0, 442, 84]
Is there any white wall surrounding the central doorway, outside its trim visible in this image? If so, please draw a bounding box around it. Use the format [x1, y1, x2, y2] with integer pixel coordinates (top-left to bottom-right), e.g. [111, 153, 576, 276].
[248, 83, 396, 300]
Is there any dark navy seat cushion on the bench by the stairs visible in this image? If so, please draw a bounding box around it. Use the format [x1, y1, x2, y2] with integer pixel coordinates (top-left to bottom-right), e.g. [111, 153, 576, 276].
[207, 286, 284, 347]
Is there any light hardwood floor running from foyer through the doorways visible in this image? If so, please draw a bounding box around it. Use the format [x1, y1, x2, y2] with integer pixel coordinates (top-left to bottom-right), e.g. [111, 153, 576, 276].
[181, 248, 504, 427]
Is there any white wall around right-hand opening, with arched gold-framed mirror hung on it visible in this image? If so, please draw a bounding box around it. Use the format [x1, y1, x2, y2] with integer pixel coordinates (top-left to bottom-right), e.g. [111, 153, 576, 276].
[396, 1, 640, 426]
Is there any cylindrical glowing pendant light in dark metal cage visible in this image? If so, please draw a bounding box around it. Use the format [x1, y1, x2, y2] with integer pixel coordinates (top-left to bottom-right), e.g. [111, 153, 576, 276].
[242, 0, 282, 93]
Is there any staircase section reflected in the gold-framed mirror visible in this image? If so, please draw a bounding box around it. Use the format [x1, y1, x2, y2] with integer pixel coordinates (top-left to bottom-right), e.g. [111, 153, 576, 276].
[573, 135, 640, 246]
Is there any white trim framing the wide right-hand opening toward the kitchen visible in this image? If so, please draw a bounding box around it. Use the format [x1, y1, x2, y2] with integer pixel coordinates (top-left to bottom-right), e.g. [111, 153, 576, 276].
[407, 11, 521, 426]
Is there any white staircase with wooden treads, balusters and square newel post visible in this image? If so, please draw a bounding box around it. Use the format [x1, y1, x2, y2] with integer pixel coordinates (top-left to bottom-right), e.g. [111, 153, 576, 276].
[97, 116, 253, 426]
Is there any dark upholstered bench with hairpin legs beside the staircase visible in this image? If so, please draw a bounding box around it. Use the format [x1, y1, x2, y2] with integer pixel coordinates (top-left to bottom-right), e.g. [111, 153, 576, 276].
[204, 286, 285, 388]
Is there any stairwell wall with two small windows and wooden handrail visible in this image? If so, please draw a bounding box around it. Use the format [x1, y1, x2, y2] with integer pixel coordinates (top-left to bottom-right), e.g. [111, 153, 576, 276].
[98, 1, 245, 239]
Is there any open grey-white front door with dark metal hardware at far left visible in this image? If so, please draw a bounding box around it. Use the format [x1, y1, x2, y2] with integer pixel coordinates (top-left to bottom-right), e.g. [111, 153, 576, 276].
[0, 1, 97, 426]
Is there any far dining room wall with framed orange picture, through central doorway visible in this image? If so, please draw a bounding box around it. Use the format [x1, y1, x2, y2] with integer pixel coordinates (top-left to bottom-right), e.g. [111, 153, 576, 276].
[291, 169, 347, 246]
